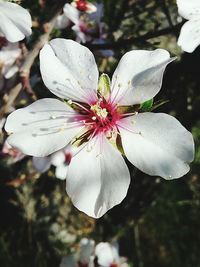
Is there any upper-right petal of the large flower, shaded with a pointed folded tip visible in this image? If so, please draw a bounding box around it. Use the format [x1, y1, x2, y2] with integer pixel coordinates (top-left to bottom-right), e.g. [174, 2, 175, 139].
[111, 49, 173, 105]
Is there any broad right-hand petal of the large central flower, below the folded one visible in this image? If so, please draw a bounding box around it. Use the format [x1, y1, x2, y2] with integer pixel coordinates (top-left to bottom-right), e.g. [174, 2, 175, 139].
[119, 113, 194, 179]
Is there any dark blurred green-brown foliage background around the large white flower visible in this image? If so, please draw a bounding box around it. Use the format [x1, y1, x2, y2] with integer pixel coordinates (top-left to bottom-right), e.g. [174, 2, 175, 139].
[0, 0, 200, 267]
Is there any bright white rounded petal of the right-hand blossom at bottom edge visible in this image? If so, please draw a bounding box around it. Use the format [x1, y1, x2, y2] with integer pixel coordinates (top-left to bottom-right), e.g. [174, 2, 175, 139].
[95, 242, 115, 267]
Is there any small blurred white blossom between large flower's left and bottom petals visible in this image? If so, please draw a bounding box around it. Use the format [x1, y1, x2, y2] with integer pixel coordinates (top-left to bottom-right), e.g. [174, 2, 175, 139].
[33, 147, 72, 180]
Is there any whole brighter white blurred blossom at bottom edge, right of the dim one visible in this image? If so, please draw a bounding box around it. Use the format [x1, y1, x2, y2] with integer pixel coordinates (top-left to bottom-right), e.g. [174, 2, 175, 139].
[95, 242, 129, 267]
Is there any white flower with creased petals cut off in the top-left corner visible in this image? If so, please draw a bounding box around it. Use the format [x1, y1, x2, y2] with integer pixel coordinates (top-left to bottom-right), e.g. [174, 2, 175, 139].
[0, 0, 32, 43]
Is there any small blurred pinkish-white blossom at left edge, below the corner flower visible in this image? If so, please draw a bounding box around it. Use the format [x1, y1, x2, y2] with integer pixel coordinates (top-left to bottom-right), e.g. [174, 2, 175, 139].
[0, 40, 21, 79]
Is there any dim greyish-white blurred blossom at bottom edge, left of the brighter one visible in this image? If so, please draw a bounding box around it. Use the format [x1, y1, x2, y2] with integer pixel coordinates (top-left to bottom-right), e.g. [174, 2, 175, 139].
[60, 238, 95, 267]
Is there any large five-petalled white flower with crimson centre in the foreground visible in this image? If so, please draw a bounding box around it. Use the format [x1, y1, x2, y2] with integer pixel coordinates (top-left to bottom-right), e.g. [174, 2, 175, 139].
[5, 39, 194, 218]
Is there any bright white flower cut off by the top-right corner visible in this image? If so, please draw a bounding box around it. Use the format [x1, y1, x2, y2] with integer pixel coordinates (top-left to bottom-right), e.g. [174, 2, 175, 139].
[177, 0, 200, 53]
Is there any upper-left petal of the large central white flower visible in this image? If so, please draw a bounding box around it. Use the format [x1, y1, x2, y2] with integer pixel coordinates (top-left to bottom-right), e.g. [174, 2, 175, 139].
[40, 38, 98, 102]
